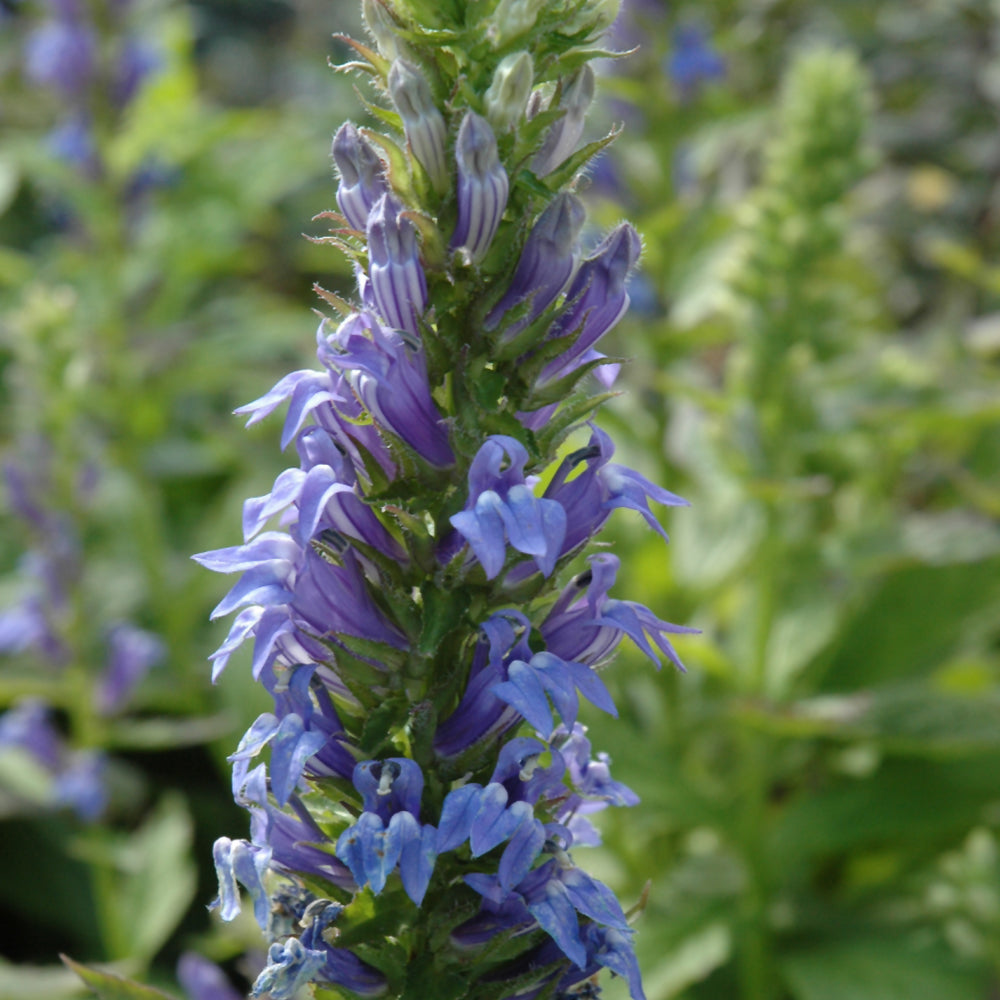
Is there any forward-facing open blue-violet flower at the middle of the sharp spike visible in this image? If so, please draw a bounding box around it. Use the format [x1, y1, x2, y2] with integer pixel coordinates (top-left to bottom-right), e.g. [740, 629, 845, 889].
[451, 434, 566, 580]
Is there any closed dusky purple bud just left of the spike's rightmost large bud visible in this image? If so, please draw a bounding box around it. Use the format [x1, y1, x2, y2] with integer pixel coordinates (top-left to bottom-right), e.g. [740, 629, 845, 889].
[484, 192, 586, 340]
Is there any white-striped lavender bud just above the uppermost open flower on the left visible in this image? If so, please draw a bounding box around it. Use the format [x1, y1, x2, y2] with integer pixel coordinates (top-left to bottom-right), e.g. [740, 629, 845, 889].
[368, 195, 427, 337]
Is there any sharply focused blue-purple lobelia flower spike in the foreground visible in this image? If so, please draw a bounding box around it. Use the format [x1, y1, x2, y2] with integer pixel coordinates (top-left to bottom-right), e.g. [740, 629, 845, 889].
[195, 0, 692, 1000]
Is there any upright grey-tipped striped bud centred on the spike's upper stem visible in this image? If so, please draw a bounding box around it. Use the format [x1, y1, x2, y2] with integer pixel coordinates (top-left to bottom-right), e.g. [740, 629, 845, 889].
[451, 111, 510, 261]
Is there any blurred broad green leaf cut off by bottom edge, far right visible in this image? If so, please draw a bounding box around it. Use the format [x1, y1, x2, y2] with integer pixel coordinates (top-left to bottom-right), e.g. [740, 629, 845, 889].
[782, 938, 986, 1000]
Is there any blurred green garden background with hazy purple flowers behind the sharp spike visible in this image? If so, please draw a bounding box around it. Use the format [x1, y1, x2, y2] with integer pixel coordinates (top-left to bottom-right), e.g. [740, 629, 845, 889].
[0, 0, 1000, 1000]
